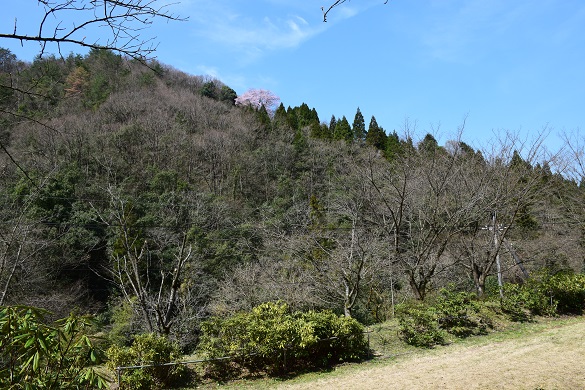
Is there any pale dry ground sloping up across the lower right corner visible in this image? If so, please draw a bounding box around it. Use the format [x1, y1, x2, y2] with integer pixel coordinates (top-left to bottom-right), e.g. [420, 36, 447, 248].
[281, 321, 585, 390]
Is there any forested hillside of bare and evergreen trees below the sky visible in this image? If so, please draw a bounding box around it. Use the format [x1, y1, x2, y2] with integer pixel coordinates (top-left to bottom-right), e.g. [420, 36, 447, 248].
[0, 50, 585, 349]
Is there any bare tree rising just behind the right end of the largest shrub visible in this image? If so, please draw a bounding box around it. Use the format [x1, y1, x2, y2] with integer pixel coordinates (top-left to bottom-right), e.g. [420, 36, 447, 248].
[292, 146, 388, 317]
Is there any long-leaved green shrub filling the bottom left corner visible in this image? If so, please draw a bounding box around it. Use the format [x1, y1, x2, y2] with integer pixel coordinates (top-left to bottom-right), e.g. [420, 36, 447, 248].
[0, 306, 106, 389]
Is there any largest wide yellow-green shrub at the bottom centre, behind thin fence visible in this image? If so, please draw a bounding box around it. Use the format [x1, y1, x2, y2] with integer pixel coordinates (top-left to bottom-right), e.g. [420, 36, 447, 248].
[199, 302, 368, 377]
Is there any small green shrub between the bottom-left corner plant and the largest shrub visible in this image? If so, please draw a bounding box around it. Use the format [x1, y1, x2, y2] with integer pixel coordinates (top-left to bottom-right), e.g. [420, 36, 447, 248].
[107, 333, 188, 390]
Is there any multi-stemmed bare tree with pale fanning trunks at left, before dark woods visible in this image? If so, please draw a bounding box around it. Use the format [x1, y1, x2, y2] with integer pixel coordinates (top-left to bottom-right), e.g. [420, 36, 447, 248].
[93, 188, 205, 335]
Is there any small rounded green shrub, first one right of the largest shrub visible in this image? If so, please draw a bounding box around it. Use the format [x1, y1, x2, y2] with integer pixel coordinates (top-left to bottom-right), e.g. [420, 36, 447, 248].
[397, 303, 445, 348]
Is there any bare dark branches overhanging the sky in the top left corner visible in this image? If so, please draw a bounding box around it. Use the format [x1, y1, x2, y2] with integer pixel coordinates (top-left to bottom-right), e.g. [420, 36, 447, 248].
[0, 0, 186, 59]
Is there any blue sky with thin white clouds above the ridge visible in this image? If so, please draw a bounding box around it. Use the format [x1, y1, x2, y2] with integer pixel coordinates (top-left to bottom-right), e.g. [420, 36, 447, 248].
[0, 0, 585, 149]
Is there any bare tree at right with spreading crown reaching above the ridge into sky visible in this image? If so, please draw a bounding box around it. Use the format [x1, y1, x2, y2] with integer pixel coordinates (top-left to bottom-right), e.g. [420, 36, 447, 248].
[451, 133, 551, 296]
